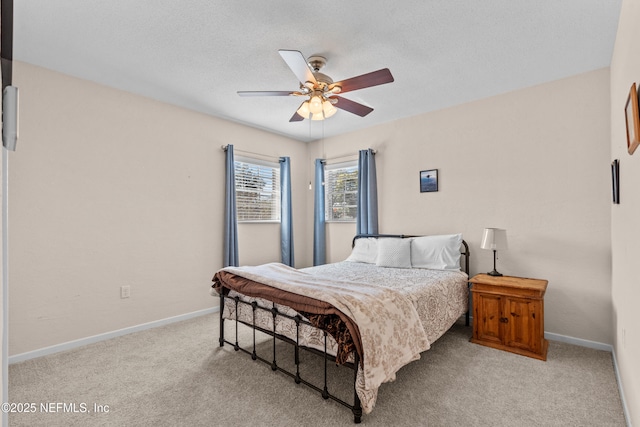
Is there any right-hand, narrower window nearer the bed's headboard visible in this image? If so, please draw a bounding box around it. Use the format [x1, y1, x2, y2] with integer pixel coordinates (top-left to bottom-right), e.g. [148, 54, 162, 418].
[324, 162, 358, 221]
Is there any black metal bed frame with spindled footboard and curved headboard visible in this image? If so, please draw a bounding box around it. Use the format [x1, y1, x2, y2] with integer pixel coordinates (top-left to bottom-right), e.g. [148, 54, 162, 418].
[218, 234, 470, 424]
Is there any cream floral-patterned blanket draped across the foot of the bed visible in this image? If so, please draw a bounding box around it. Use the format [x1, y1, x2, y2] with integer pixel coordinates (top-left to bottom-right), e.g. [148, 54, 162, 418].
[219, 263, 430, 413]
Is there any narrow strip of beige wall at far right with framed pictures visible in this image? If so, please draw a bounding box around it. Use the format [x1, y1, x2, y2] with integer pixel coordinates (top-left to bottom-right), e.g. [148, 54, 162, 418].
[611, 0, 640, 425]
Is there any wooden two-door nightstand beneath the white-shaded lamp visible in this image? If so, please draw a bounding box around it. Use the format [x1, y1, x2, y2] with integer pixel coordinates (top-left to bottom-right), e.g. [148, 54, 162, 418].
[469, 274, 549, 360]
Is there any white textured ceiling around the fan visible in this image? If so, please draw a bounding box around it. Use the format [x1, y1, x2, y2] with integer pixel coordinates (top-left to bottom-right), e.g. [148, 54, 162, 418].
[13, 0, 621, 141]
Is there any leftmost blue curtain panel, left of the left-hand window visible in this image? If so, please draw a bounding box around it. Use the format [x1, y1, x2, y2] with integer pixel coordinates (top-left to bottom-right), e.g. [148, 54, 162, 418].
[222, 144, 240, 267]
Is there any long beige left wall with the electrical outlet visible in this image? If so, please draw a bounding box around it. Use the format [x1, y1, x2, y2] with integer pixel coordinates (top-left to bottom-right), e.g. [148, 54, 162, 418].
[9, 63, 306, 355]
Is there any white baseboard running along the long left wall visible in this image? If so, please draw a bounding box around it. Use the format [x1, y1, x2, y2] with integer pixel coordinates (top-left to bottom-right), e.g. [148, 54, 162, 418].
[9, 307, 219, 365]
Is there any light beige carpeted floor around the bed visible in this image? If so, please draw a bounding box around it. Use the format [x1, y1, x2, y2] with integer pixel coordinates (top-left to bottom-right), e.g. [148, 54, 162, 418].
[9, 314, 625, 427]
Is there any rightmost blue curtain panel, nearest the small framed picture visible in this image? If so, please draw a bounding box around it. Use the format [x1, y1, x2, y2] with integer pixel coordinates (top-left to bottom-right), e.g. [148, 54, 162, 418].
[356, 148, 378, 234]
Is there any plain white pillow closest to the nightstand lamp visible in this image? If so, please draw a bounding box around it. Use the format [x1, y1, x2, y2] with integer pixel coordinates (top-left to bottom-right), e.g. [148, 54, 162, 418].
[411, 234, 462, 270]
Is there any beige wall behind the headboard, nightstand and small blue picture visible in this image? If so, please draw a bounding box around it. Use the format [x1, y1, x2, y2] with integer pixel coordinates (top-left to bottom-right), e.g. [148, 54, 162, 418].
[311, 69, 613, 344]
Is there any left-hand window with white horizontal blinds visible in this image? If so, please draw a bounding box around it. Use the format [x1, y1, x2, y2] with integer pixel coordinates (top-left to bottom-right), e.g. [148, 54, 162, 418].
[234, 157, 280, 222]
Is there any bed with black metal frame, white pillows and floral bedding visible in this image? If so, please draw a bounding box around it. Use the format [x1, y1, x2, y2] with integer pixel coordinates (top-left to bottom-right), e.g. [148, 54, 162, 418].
[212, 234, 469, 423]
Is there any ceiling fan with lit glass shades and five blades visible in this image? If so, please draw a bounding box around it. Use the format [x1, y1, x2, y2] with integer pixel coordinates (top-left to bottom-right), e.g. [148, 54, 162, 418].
[238, 49, 393, 122]
